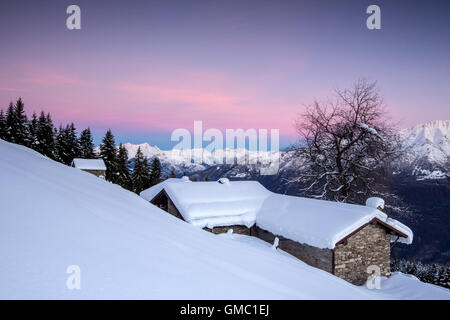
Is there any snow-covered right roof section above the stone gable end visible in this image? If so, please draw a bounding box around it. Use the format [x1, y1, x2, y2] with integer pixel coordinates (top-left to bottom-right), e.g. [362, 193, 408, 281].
[256, 193, 413, 249]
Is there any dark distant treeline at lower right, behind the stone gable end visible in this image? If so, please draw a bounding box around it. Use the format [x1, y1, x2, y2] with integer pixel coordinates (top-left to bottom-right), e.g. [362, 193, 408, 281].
[391, 258, 450, 289]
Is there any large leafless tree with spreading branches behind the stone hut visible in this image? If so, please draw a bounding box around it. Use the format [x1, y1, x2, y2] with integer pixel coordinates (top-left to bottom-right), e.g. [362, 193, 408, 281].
[296, 79, 400, 203]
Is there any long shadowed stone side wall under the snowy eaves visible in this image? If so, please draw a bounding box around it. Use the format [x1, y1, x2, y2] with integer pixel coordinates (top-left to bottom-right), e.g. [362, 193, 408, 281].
[251, 225, 333, 273]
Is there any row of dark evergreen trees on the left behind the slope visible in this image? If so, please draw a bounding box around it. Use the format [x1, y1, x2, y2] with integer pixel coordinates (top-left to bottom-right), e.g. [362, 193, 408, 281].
[0, 98, 162, 194]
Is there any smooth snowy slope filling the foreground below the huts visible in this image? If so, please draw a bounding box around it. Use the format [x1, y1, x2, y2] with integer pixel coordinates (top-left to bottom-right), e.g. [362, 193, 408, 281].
[0, 140, 450, 299]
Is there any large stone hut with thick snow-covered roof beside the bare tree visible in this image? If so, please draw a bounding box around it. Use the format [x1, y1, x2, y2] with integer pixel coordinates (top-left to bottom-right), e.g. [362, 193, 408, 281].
[141, 178, 412, 285]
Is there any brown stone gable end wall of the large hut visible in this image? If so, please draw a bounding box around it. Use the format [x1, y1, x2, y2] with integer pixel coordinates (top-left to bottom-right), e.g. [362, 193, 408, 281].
[334, 224, 390, 285]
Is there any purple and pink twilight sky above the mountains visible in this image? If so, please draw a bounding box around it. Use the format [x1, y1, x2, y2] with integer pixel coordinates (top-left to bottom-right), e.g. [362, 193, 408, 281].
[0, 0, 450, 150]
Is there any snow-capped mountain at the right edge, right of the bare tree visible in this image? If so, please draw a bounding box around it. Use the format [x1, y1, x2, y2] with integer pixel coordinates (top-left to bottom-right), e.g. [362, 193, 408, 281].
[400, 120, 450, 180]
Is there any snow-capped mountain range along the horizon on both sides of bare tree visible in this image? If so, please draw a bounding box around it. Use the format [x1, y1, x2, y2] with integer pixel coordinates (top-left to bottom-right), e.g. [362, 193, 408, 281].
[117, 120, 450, 180]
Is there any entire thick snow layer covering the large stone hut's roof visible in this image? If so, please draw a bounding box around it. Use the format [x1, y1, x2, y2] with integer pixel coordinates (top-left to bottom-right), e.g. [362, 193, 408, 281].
[141, 178, 413, 249]
